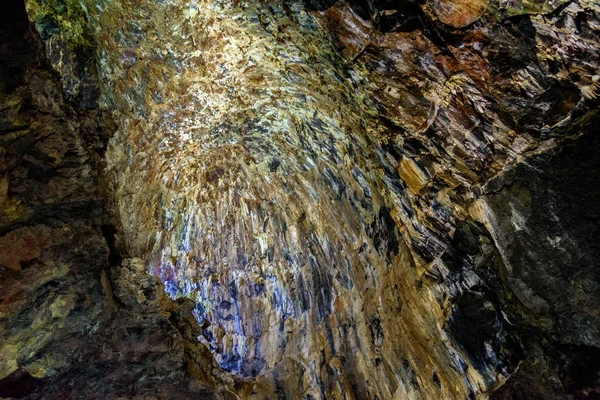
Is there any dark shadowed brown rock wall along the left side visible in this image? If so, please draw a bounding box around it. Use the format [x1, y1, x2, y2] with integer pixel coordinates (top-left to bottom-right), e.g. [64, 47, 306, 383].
[0, 2, 234, 399]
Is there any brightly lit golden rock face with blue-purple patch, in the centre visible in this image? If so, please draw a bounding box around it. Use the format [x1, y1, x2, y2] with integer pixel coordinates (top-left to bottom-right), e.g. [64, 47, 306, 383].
[90, 2, 460, 398]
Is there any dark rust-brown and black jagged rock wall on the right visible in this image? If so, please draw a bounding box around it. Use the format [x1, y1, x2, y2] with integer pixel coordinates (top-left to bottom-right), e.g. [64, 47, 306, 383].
[314, 2, 600, 398]
